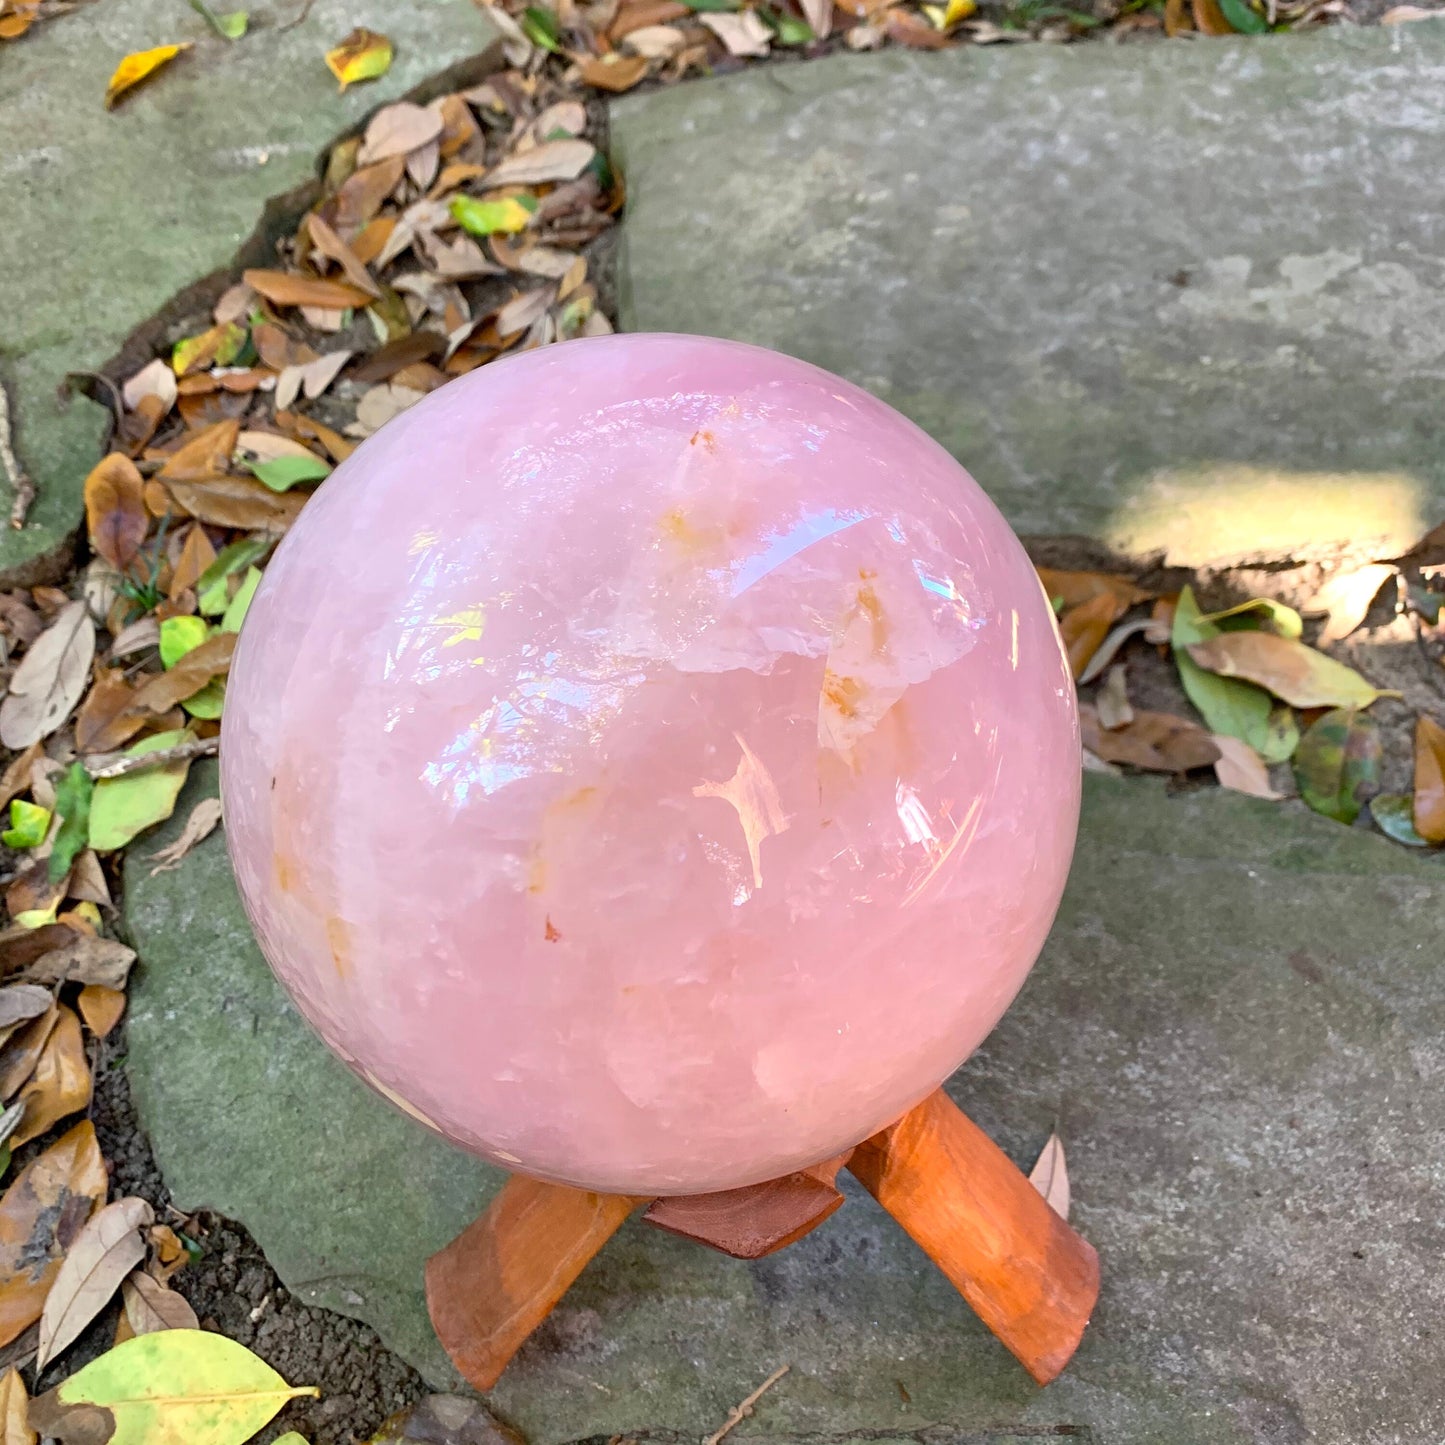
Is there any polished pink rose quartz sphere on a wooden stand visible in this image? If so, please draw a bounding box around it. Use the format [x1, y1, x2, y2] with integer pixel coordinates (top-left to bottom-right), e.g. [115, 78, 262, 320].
[221, 335, 1079, 1195]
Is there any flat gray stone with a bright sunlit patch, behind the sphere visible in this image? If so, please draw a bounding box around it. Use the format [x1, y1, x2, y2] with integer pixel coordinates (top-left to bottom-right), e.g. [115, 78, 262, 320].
[613, 22, 1445, 565]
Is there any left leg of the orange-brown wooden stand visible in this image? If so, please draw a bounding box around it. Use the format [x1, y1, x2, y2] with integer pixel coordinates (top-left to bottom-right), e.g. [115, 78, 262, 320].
[426, 1175, 642, 1390]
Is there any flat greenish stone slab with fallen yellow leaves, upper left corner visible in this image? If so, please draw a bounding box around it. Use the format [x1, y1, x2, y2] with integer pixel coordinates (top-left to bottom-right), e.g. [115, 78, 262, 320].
[0, 0, 496, 585]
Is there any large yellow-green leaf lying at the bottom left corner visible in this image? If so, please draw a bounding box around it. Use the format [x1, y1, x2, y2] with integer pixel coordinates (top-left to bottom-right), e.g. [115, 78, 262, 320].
[30, 1329, 321, 1445]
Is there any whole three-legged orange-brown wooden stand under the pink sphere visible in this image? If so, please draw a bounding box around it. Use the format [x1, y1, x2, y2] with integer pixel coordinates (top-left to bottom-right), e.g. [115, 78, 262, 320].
[426, 1090, 1098, 1390]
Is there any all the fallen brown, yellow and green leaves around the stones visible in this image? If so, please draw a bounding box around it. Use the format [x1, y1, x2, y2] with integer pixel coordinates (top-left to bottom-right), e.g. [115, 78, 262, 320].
[0, 0, 1445, 1445]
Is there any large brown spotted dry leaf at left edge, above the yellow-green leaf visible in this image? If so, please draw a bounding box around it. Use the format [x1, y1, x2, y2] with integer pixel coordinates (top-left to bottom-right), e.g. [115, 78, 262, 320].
[0, 1118, 110, 1345]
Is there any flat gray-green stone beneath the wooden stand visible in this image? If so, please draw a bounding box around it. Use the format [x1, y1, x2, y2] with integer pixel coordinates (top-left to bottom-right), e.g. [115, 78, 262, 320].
[126, 766, 1445, 1445]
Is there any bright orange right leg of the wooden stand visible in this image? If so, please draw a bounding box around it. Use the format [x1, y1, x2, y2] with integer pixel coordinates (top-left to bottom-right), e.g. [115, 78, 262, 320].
[848, 1090, 1098, 1384]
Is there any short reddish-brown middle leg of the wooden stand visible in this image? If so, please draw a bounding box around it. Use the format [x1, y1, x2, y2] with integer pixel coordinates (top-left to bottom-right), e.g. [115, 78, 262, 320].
[643, 1155, 847, 1260]
